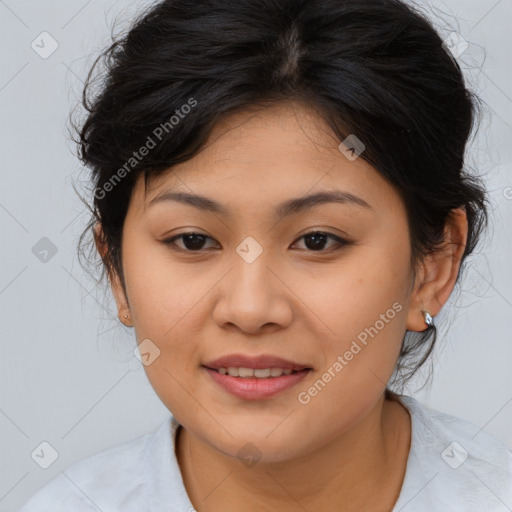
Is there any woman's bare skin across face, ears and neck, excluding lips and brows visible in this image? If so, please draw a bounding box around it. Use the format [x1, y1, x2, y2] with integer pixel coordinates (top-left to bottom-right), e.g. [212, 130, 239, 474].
[97, 103, 467, 512]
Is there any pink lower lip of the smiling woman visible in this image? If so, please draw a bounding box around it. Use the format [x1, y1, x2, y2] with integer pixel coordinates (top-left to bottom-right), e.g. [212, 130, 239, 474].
[205, 367, 311, 400]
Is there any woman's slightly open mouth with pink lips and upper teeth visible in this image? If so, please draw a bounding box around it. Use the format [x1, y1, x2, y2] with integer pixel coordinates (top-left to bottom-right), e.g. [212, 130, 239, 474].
[202, 354, 313, 400]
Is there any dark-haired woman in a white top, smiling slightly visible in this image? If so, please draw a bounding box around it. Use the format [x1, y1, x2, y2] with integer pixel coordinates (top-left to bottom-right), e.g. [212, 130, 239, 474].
[17, 0, 512, 512]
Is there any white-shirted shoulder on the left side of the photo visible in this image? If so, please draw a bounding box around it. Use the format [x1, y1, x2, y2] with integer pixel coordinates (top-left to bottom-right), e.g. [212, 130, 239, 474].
[19, 418, 171, 512]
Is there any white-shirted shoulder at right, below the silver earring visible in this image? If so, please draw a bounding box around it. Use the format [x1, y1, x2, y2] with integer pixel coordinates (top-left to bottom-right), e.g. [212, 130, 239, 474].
[399, 396, 512, 512]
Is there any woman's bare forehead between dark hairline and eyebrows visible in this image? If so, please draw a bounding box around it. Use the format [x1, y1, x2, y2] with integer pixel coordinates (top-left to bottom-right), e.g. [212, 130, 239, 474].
[138, 103, 399, 217]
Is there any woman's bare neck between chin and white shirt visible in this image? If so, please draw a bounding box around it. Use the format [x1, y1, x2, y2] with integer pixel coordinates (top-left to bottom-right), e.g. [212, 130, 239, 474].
[176, 395, 410, 512]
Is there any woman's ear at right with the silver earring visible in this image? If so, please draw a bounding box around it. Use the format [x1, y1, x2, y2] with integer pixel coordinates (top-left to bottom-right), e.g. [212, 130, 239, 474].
[406, 208, 468, 332]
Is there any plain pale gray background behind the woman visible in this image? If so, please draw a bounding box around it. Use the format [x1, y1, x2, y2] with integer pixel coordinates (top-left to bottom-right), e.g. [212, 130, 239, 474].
[0, 0, 512, 512]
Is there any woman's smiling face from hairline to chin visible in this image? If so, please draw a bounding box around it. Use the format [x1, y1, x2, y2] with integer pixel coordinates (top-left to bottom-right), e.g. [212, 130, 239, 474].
[108, 103, 420, 461]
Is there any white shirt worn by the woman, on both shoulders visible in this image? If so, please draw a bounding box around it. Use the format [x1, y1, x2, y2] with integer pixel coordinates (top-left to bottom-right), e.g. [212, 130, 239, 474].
[19, 396, 512, 512]
